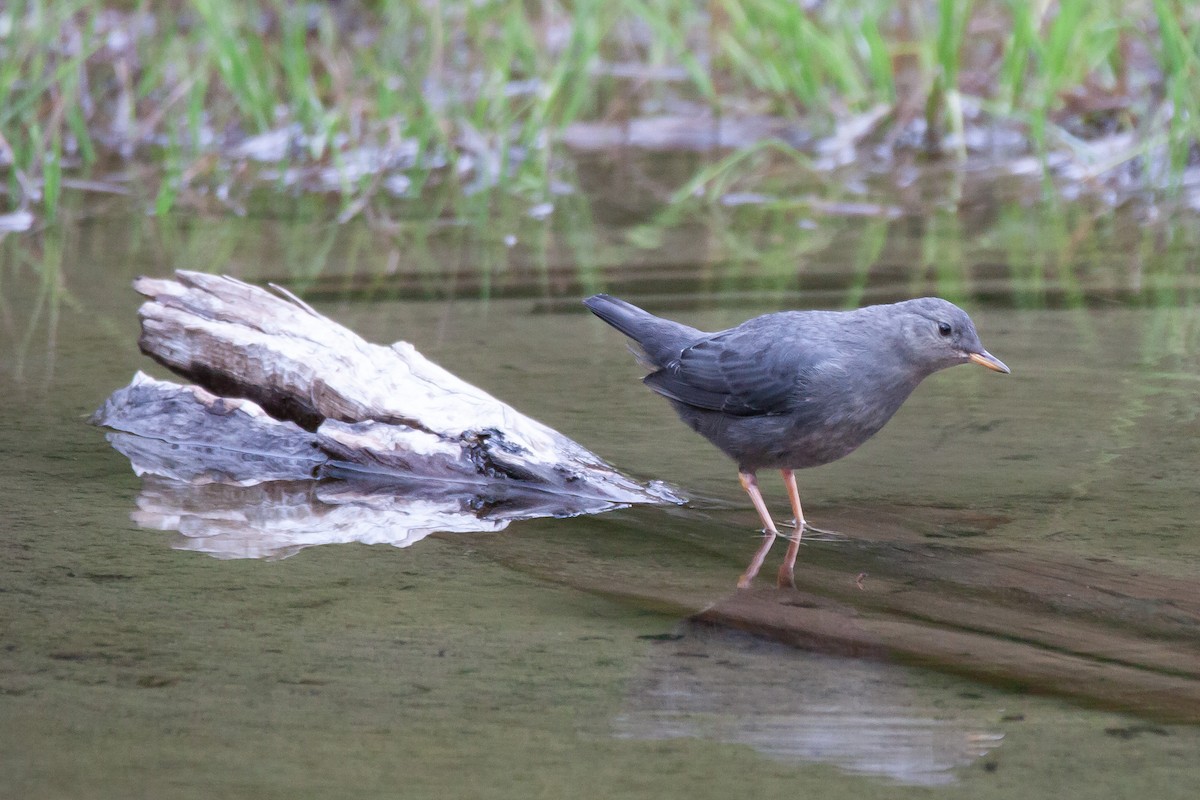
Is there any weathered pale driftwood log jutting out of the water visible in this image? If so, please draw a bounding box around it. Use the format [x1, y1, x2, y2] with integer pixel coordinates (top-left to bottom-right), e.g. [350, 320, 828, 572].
[92, 271, 678, 516]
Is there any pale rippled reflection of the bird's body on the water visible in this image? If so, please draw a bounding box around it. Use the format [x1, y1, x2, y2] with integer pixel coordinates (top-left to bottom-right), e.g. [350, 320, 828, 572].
[614, 621, 1001, 786]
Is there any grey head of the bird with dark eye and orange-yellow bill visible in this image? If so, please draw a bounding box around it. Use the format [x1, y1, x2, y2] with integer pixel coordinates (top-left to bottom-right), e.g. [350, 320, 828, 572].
[896, 297, 1009, 373]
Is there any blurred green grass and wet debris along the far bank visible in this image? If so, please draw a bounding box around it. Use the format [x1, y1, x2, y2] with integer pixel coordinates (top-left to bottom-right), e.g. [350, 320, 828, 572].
[7, 0, 1200, 228]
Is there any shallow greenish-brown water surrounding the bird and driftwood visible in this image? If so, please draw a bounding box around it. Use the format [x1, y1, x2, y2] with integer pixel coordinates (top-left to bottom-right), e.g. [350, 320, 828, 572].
[0, 178, 1200, 798]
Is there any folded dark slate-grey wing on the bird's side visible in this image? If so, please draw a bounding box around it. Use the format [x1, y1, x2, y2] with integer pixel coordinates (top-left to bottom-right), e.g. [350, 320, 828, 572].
[644, 327, 829, 416]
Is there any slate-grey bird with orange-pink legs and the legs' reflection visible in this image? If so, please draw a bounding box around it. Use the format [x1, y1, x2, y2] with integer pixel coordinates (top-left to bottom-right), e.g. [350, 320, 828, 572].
[583, 294, 1008, 589]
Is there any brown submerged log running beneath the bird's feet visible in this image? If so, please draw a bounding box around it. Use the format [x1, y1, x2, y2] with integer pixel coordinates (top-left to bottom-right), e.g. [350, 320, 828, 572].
[472, 506, 1200, 735]
